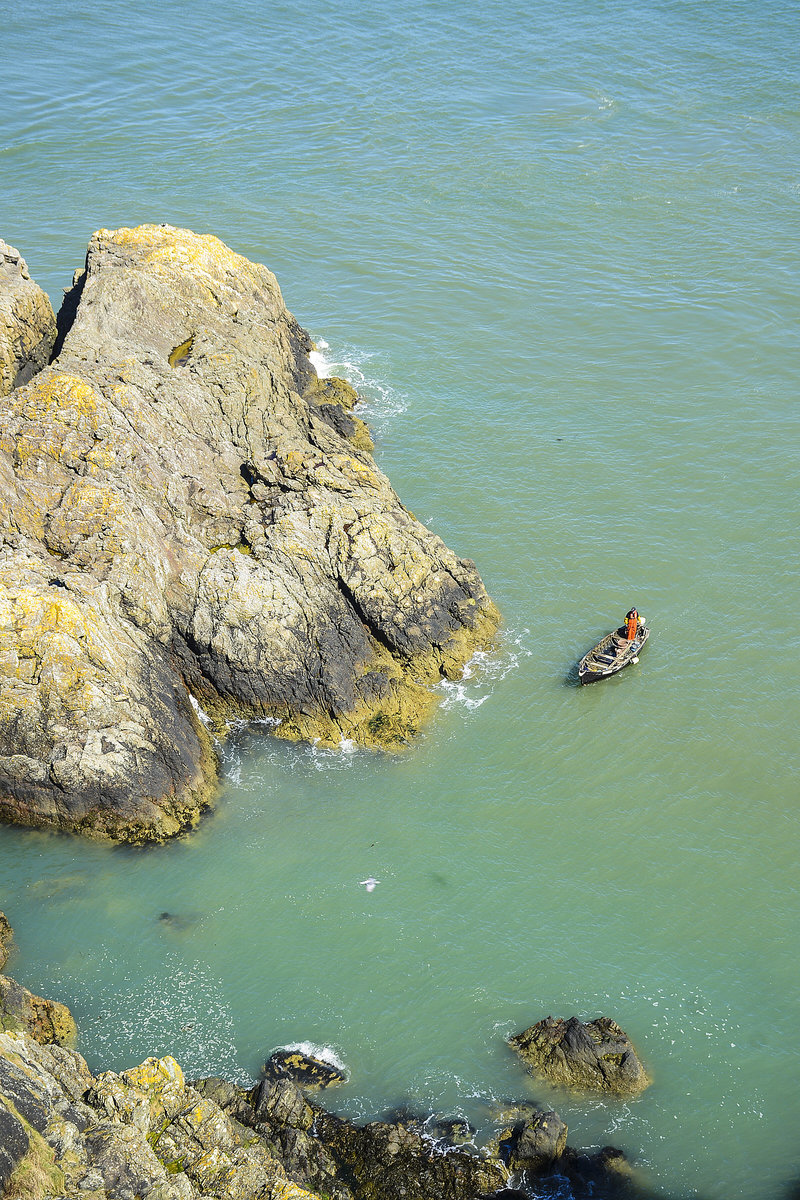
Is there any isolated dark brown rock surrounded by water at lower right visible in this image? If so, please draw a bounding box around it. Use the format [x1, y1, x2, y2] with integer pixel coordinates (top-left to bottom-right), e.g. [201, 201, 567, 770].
[509, 1016, 650, 1096]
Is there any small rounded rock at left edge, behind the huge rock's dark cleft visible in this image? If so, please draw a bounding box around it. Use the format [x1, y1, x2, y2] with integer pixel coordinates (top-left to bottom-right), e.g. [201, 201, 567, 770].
[0, 239, 55, 396]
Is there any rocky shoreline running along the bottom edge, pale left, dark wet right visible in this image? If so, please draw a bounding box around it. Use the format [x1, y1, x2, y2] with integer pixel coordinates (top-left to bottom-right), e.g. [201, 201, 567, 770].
[0, 914, 676, 1200]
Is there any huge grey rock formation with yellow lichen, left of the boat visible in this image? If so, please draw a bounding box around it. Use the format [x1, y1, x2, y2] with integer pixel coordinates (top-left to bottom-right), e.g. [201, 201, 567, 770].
[0, 226, 498, 841]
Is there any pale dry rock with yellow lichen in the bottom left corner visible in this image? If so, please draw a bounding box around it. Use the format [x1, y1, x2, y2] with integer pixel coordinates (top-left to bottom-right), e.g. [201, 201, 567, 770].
[0, 1033, 318, 1200]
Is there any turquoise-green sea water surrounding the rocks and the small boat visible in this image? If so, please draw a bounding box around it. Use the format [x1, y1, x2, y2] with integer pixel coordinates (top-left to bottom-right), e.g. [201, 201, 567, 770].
[0, 0, 800, 1200]
